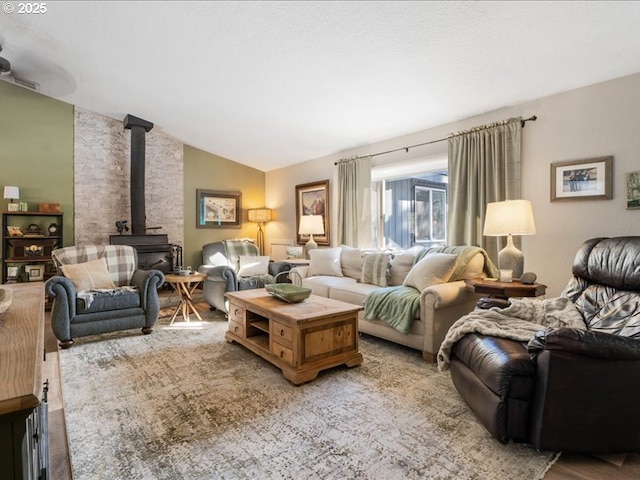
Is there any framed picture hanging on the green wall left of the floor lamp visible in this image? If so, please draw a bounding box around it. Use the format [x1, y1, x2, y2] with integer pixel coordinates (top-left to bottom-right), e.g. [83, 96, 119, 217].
[196, 189, 242, 228]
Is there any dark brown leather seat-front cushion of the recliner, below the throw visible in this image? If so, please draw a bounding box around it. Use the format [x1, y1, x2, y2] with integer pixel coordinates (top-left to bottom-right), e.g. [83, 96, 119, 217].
[453, 333, 535, 399]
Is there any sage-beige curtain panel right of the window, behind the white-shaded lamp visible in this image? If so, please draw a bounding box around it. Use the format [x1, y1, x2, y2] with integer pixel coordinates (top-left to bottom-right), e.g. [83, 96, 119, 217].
[447, 117, 522, 265]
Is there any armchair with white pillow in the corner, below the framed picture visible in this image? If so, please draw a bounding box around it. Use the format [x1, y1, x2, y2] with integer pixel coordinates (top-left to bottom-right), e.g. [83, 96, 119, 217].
[198, 240, 290, 313]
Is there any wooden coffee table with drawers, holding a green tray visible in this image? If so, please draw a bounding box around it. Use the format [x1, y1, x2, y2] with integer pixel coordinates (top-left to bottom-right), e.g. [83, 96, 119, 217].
[225, 288, 363, 385]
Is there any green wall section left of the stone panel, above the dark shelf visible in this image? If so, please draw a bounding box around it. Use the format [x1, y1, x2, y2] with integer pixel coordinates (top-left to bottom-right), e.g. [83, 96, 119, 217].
[0, 81, 73, 245]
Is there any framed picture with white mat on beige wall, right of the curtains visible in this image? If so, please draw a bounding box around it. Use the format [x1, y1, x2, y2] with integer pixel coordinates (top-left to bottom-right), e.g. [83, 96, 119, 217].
[551, 156, 613, 202]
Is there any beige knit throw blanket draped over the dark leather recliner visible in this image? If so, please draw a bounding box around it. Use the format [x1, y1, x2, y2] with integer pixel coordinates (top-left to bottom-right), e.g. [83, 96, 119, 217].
[438, 297, 587, 371]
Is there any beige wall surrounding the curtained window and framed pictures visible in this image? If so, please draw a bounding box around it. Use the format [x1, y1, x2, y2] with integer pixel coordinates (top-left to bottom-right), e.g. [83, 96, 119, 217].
[266, 75, 640, 296]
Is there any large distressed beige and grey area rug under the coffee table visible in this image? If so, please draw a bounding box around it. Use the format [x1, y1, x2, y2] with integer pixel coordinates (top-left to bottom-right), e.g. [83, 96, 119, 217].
[60, 308, 556, 480]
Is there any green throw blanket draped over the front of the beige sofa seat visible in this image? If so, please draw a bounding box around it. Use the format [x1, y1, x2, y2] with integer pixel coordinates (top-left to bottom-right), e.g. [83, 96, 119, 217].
[364, 285, 420, 334]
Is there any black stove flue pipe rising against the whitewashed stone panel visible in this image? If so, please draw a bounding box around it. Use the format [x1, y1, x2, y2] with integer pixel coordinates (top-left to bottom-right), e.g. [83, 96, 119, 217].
[123, 115, 153, 235]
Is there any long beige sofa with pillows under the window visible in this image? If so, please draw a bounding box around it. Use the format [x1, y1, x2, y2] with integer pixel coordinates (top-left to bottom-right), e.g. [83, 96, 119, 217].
[292, 246, 497, 362]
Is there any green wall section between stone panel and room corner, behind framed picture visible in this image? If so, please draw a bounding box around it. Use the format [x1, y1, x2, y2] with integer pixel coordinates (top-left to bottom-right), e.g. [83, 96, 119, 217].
[183, 145, 265, 269]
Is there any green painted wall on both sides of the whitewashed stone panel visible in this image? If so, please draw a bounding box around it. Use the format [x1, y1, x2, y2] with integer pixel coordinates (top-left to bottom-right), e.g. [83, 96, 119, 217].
[0, 81, 265, 269]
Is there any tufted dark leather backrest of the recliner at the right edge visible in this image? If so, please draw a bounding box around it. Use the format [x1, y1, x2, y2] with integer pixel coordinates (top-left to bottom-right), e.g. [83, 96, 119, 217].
[561, 237, 640, 338]
